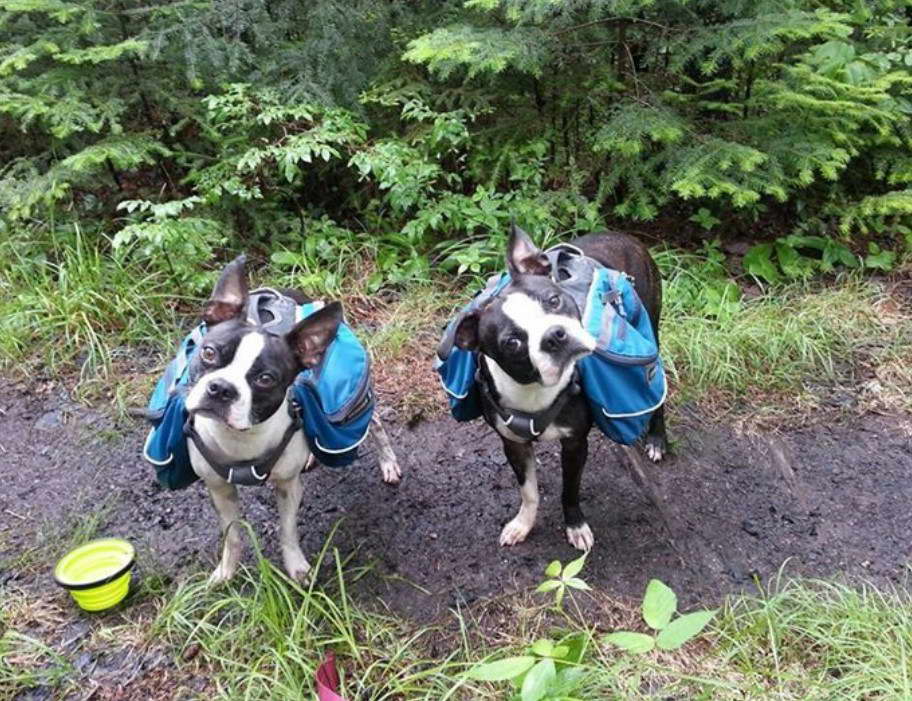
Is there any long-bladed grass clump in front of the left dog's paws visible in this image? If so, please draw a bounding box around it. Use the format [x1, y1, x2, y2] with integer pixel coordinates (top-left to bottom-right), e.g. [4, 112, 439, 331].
[154, 534, 481, 699]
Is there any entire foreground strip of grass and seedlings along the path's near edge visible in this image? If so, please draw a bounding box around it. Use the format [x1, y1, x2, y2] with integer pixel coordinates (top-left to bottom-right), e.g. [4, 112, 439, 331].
[0, 548, 912, 701]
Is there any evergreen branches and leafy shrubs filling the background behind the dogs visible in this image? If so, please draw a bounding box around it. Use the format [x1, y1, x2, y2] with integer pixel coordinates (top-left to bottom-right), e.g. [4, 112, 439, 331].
[0, 0, 912, 292]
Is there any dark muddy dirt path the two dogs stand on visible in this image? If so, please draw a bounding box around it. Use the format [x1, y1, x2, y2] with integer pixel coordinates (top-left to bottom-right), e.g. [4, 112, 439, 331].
[0, 381, 912, 620]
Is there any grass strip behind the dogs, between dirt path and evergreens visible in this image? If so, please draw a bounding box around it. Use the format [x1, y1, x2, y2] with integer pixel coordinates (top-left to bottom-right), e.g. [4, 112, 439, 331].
[0, 228, 912, 416]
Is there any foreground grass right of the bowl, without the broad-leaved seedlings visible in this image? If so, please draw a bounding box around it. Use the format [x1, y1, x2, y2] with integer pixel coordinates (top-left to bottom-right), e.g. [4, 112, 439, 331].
[155, 551, 912, 701]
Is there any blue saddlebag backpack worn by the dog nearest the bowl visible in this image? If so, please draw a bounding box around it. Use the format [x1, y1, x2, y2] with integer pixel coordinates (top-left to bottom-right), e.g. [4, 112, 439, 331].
[143, 288, 374, 489]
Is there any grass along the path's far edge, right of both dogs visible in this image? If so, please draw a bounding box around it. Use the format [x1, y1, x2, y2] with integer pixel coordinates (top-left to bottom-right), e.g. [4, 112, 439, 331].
[656, 250, 912, 404]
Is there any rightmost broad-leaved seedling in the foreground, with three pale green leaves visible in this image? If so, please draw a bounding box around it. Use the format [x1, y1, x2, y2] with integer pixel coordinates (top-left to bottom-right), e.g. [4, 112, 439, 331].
[604, 579, 717, 654]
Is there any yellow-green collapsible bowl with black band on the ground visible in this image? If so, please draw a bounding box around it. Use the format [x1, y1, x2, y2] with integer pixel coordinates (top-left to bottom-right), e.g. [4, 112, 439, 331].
[54, 538, 136, 611]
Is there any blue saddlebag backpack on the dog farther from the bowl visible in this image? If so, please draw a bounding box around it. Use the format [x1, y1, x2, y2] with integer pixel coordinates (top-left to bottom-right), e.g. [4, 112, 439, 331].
[434, 244, 668, 445]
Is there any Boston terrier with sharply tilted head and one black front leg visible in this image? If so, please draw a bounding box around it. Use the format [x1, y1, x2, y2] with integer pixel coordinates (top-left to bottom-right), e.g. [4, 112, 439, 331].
[455, 227, 666, 550]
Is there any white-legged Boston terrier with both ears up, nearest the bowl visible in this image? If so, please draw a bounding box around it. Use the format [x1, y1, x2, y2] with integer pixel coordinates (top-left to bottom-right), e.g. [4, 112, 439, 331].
[186, 256, 401, 584]
